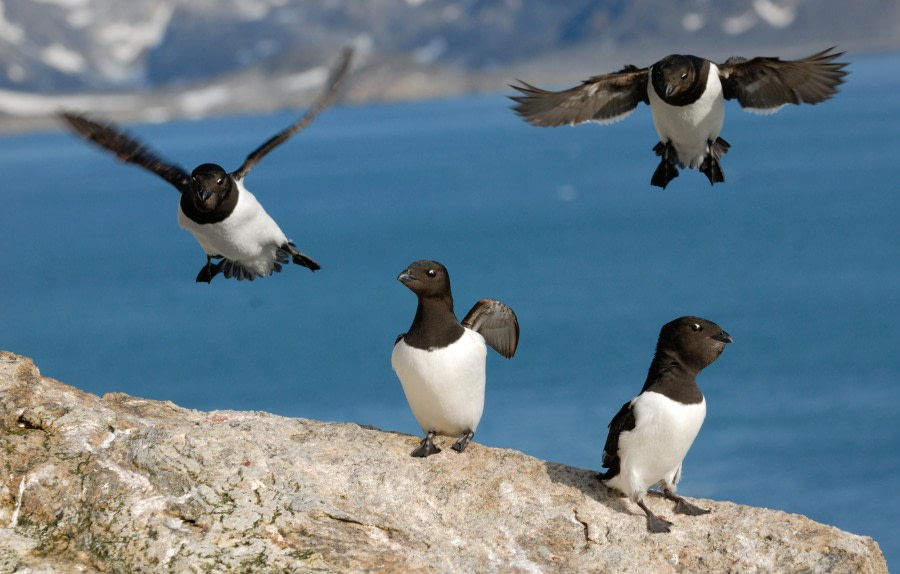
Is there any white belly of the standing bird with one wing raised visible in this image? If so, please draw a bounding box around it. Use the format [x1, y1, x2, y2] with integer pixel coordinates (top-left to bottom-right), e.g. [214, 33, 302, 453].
[391, 329, 487, 436]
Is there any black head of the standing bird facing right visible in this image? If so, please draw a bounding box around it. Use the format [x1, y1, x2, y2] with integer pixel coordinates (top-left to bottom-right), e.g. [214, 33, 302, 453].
[656, 317, 733, 372]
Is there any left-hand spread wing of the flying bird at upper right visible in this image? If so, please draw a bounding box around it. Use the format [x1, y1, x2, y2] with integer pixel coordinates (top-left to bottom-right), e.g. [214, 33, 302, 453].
[510, 66, 650, 127]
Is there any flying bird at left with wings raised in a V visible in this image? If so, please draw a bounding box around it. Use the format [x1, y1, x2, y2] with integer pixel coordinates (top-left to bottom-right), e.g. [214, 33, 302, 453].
[61, 49, 353, 283]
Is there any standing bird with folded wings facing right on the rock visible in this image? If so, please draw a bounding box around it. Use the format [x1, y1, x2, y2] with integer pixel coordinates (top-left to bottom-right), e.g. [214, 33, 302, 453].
[597, 317, 732, 532]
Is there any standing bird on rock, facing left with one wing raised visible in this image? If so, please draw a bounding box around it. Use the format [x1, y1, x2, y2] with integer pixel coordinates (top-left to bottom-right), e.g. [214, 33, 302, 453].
[391, 261, 519, 457]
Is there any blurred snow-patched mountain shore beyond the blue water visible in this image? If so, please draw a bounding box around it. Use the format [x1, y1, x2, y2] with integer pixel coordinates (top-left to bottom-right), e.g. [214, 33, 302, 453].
[0, 0, 900, 129]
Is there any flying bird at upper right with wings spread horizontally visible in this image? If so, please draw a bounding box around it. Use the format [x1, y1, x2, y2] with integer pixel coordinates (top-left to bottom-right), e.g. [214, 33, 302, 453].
[510, 47, 847, 188]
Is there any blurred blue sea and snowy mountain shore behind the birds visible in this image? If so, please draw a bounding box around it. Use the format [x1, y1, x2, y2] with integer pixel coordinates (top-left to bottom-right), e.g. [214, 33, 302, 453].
[0, 0, 900, 564]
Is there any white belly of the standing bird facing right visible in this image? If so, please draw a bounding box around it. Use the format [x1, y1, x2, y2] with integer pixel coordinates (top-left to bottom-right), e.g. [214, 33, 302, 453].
[607, 392, 706, 499]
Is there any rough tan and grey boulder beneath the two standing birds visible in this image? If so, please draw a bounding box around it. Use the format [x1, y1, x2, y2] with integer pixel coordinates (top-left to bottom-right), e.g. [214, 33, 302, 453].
[0, 352, 887, 574]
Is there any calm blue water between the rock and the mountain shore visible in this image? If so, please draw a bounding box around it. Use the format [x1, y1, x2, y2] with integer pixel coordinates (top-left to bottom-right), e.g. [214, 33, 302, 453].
[0, 51, 900, 563]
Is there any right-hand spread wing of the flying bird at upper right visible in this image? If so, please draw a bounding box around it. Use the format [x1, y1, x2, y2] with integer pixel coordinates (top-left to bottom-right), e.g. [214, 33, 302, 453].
[718, 46, 848, 113]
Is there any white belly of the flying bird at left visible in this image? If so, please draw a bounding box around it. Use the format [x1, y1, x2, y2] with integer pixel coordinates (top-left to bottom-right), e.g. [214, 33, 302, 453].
[178, 183, 287, 276]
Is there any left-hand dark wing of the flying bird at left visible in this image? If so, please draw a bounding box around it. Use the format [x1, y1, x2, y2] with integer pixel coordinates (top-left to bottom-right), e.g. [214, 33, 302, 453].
[59, 112, 191, 192]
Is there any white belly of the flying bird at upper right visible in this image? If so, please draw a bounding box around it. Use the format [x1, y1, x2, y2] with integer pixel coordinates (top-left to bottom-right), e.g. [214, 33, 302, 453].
[647, 64, 725, 168]
